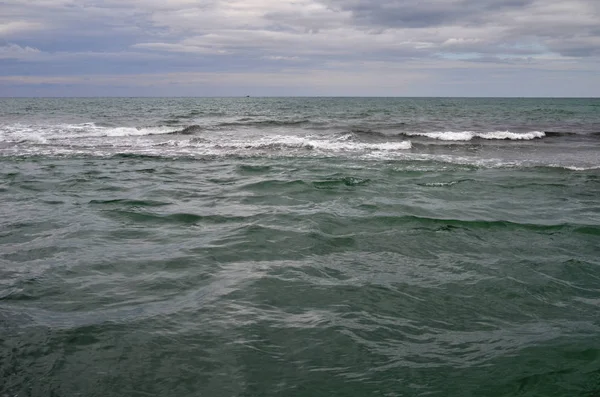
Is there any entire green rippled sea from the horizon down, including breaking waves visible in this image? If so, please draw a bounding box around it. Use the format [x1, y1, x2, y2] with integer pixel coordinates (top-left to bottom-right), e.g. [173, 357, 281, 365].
[0, 98, 600, 397]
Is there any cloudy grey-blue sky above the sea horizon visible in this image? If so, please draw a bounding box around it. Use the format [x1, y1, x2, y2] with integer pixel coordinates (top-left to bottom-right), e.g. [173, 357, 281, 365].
[0, 0, 600, 97]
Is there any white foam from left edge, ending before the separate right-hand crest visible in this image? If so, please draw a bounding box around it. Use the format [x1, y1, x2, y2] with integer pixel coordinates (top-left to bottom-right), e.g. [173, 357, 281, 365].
[0, 123, 412, 157]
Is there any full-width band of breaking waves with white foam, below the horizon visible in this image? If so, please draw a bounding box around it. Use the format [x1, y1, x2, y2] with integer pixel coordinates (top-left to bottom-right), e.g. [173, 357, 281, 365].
[0, 123, 600, 171]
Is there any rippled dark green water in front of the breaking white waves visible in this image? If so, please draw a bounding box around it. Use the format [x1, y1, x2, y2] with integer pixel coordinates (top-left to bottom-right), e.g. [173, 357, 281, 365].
[0, 152, 600, 397]
